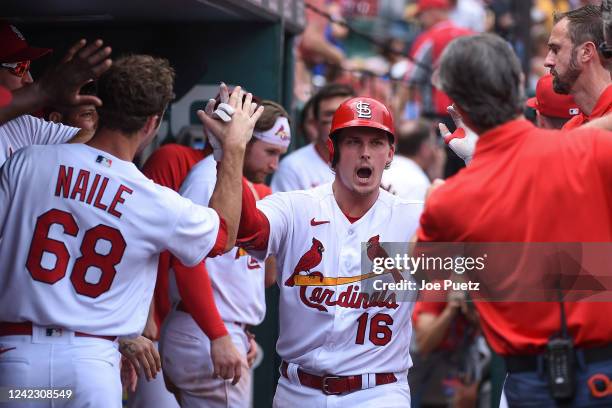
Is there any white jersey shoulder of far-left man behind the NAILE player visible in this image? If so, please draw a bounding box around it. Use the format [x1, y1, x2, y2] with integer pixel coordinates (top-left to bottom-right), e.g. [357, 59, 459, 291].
[0, 115, 79, 166]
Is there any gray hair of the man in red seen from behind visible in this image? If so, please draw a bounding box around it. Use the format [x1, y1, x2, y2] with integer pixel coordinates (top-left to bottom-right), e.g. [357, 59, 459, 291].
[439, 34, 524, 131]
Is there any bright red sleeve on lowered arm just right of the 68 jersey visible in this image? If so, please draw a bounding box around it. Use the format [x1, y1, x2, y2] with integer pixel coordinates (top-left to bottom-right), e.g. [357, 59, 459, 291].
[170, 257, 228, 341]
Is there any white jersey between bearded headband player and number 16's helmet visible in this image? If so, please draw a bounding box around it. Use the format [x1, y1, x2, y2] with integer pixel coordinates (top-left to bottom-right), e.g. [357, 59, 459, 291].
[270, 143, 335, 193]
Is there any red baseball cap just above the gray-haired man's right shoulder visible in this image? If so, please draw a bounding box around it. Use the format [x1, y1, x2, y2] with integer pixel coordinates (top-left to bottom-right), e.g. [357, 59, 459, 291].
[527, 74, 580, 119]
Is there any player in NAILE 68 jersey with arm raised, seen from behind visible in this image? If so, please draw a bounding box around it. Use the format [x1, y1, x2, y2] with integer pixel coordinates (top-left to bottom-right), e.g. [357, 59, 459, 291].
[0, 55, 262, 407]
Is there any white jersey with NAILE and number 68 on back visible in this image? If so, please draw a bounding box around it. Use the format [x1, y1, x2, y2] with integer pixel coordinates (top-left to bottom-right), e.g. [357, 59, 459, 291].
[0, 144, 220, 336]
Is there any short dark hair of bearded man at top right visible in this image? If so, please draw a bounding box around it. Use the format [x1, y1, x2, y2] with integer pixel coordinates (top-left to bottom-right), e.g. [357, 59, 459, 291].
[554, 4, 604, 51]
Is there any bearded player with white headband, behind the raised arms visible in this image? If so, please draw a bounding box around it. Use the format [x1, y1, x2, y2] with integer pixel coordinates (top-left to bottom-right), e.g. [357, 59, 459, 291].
[161, 101, 291, 408]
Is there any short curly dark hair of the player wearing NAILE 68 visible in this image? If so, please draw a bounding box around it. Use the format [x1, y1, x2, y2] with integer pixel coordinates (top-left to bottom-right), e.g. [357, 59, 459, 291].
[98, 55, 174, 134]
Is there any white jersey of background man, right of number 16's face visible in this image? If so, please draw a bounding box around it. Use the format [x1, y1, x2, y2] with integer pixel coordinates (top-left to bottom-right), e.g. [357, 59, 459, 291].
[380, 154, 431, 201]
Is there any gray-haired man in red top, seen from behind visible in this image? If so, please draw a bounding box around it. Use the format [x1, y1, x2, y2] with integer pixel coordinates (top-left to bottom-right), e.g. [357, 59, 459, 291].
[417, 35, 612, 407]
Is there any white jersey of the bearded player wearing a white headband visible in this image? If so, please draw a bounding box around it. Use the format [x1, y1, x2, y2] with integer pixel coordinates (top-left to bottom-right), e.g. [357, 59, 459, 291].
[171, 155, 266, 326]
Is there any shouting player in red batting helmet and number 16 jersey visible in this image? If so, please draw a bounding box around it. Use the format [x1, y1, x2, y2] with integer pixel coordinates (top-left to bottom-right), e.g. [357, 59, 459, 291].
[238, 97, 422, 407]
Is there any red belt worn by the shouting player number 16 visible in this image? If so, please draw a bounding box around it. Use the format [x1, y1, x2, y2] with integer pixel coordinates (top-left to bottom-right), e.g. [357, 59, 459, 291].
[281, 361, 397, 395]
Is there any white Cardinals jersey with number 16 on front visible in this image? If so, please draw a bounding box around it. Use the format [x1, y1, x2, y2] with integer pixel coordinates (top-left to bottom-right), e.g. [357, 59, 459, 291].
[257, 183, 422, 375]
